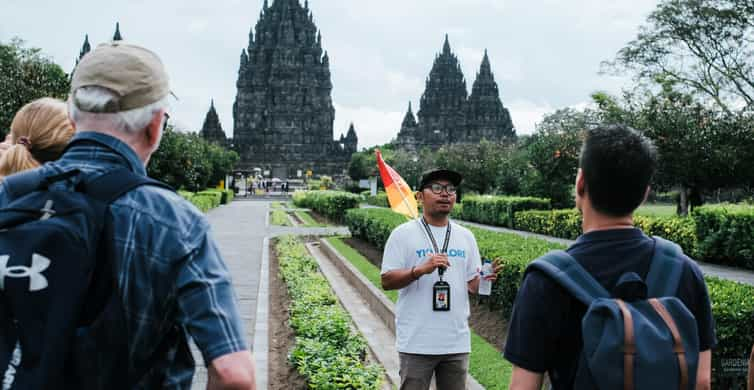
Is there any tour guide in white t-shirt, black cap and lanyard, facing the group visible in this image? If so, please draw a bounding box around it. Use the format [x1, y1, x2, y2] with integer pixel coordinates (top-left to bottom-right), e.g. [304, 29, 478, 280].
[382, 169, 497, 390]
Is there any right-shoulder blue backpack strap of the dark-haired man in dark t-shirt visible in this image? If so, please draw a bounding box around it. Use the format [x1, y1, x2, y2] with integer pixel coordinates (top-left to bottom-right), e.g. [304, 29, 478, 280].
[647, 236, 684, 298]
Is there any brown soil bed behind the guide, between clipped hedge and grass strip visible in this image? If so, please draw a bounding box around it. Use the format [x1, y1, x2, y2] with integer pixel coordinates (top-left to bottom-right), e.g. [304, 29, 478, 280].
[344, 238, 508, 351]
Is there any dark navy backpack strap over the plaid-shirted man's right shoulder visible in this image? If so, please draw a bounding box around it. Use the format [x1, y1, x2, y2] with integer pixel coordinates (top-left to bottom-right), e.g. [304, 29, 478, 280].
[81, 168, 175, 204]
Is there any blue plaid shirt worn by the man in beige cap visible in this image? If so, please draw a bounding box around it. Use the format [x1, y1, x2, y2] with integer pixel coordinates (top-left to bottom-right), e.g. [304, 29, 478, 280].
[0, 132, 248, 389]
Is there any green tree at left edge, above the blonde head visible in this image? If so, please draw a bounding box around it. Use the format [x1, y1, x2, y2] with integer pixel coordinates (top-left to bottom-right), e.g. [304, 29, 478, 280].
[0, 38, 69, 136]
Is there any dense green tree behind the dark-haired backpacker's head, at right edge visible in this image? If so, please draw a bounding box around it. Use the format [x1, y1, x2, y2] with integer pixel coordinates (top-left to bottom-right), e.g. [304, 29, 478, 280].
[594, 82, 754, 215]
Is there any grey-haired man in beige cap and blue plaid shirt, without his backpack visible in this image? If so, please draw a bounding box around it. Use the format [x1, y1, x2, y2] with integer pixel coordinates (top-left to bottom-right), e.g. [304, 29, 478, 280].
[0, 41, 255, 389]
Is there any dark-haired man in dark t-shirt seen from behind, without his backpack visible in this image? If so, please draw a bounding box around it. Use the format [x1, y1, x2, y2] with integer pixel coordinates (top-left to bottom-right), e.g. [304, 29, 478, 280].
[504, 126, 717, 390]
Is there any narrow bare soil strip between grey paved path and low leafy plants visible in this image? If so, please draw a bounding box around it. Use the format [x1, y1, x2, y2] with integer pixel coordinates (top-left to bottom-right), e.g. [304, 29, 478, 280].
[267, 243, 307, 390]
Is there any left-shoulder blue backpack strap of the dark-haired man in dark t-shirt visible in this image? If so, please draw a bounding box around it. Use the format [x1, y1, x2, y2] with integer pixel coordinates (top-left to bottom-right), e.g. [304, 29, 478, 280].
[527, 251, 610, 306]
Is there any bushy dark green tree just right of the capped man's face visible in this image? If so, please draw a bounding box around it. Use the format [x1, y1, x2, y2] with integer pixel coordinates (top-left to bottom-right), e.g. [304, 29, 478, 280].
[148, 126, 239, 191]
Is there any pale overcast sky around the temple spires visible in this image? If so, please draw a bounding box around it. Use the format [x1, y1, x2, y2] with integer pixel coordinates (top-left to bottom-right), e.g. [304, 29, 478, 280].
[0, 0, 657, 148]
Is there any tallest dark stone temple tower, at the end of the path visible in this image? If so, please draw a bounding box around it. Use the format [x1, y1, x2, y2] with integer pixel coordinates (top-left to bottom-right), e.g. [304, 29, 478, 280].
[226, 0, 358, 178]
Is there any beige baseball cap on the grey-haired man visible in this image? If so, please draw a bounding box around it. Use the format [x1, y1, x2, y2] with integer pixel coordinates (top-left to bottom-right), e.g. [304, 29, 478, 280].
[71, 41, 171, 112]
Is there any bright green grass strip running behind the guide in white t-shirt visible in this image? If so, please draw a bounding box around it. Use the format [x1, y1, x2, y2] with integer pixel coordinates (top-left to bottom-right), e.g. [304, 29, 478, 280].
[326, 237, 512, 390]
